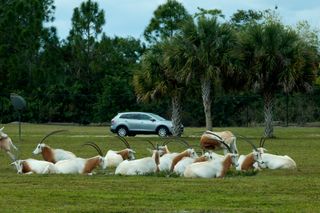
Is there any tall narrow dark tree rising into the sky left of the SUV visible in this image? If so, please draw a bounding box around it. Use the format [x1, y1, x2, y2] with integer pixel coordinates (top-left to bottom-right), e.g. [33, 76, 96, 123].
[68, 0, 105, 123]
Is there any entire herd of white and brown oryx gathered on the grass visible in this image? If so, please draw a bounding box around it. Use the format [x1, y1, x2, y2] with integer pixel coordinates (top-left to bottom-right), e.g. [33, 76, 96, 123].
[0, 127, 296, 178]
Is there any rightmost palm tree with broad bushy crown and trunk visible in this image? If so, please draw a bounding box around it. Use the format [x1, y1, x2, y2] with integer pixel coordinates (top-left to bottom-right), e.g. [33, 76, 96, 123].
[239, 20, 316, 137]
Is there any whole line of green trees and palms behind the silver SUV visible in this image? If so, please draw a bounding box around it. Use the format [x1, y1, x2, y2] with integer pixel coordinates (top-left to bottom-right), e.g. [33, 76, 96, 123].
[0, 0, 320, 137]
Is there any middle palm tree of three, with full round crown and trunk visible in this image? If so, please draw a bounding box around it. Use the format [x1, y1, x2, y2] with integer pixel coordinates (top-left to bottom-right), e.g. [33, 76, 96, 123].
[165, 15, 236, 130]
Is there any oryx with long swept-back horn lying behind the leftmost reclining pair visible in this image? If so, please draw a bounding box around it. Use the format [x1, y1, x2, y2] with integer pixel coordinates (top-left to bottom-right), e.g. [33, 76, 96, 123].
[32, 130, 77, 163]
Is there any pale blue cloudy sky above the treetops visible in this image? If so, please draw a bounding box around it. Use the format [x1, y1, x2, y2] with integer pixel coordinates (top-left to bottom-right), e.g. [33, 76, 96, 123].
[52, 0, 320, 39]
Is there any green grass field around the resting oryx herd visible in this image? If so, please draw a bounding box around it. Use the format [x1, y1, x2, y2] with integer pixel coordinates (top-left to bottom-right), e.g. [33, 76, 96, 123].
[0, 124, 320, 212]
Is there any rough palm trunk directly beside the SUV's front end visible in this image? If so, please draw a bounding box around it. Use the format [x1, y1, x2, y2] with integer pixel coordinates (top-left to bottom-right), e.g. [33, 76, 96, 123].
[171, 92, 182, 136]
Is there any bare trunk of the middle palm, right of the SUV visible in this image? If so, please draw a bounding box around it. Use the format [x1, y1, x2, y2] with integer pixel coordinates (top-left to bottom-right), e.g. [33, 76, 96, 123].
[201, 79, 212, 131]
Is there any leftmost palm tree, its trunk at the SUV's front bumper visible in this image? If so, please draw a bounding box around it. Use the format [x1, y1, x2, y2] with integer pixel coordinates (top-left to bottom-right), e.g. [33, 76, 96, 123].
[133, 43, 184, 136]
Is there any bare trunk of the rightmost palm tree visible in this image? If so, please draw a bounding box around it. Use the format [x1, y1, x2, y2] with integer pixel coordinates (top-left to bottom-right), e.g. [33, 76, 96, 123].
[263, 92, 274, 138]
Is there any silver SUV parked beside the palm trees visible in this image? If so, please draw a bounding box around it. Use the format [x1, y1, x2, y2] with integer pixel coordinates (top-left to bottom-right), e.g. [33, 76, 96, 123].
[110, 112, 181, 137]
